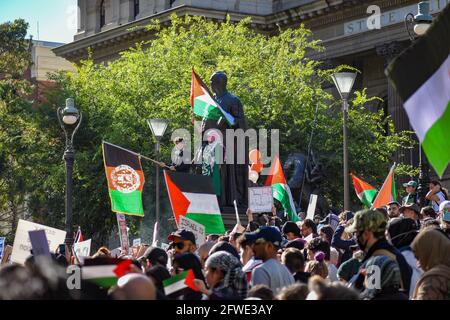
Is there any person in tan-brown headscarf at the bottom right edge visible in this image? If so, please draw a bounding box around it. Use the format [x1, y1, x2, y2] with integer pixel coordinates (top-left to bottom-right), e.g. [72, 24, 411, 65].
[411, 227, 450, 300]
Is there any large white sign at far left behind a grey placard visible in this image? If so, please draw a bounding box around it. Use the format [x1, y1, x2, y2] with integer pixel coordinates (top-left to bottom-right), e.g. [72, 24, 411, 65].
[11, 219, 66, 264]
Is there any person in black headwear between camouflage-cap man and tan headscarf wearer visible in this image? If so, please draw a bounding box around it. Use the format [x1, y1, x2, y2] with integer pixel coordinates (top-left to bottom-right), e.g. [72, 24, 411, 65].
[386, 218, 423, 298]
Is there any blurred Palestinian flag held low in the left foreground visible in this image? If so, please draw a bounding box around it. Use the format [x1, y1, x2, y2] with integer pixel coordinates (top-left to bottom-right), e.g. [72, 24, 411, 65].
[81, 257, 132, 288]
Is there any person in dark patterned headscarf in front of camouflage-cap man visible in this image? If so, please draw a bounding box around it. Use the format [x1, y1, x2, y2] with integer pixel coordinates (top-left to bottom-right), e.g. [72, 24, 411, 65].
[361, 255, 408, 300]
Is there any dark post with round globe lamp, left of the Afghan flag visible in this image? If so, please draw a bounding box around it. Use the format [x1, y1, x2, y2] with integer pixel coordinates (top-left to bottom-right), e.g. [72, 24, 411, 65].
[57, 98, 82, 246]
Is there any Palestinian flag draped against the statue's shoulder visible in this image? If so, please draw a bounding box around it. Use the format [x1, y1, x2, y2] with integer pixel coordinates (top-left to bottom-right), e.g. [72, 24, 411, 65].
[191, 69, 235, 125]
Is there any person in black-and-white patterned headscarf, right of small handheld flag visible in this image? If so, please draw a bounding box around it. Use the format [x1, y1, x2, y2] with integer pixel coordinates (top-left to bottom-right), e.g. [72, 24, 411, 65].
[194, 251, 248, 300]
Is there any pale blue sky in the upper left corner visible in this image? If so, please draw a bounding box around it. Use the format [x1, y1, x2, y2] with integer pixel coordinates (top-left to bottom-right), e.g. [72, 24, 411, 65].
[0, 0, 78, 43]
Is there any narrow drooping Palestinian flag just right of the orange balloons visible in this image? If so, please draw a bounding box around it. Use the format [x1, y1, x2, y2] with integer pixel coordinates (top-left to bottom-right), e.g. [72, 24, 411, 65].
[264, 157, 300, 222]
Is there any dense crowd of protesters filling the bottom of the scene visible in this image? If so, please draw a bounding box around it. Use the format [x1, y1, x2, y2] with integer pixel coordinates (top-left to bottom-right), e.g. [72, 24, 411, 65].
[0, 181, 450, 300]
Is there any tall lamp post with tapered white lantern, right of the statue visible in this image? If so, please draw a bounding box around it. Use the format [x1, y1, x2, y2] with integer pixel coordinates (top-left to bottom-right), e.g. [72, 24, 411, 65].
[331, 72, 356, 210]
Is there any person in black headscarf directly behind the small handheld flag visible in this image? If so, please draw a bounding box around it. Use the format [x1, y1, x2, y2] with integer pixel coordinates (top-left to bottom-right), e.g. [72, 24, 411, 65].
[172, 253, 205, 300]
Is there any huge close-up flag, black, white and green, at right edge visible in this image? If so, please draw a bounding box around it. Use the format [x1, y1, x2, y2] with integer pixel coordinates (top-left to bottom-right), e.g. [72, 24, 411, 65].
[385, 5, 450, 178]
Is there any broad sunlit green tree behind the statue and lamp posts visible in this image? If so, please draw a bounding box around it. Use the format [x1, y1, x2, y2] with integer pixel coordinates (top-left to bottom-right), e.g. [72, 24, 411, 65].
[6, 16, 411, 244]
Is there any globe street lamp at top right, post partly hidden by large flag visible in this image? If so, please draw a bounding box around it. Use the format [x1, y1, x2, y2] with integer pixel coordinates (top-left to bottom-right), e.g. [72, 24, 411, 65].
[405, 1, 433, 207]
